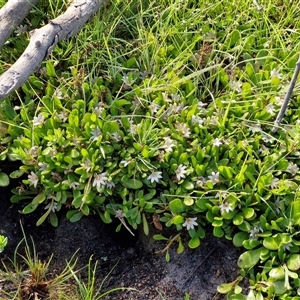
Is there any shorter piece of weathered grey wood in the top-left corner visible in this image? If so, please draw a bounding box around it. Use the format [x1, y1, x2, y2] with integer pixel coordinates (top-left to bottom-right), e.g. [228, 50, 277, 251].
[0, 0, 38, 48]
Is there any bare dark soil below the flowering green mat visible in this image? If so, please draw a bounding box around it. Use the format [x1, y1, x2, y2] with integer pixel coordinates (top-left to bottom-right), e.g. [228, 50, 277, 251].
[0, 163, 245, 300]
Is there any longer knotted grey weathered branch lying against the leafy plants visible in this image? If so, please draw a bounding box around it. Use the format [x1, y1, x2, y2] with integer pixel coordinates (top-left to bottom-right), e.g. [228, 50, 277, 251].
[0, 0, 105, 100]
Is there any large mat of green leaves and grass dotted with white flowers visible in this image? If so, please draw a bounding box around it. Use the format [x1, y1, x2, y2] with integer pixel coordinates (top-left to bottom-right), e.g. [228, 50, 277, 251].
[0, 0, 300, 299]
